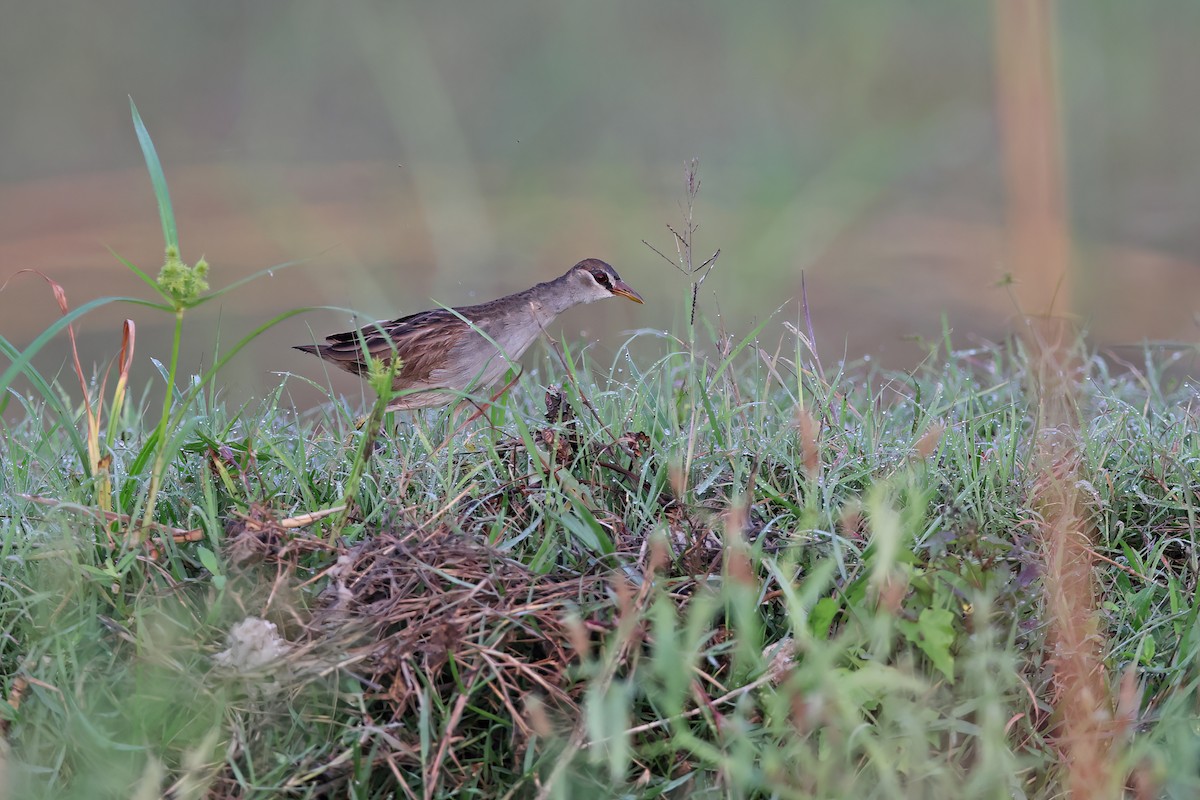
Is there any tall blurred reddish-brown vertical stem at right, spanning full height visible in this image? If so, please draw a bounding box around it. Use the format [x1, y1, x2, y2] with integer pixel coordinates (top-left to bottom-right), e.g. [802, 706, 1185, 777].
[994, 0, 1122, 799]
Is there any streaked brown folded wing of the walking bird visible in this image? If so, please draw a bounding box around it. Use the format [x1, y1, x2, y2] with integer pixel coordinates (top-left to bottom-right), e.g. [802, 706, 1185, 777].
[298, 308, 470, 385]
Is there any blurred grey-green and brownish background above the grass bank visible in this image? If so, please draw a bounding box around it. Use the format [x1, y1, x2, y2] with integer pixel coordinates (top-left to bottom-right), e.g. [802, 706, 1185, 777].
[0, 0, 1200, 402]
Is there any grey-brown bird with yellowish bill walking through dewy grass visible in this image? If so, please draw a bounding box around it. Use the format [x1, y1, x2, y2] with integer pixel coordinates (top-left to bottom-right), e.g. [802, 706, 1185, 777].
[294, 258, 643, 411]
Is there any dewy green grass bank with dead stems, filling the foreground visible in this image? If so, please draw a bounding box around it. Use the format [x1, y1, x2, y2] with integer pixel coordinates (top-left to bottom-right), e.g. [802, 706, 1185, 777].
[0, 134, 1200, 799]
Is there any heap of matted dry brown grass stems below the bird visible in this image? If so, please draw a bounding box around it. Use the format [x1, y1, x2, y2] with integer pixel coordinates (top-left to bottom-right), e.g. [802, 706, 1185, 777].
[220, 509, 612, 796]
